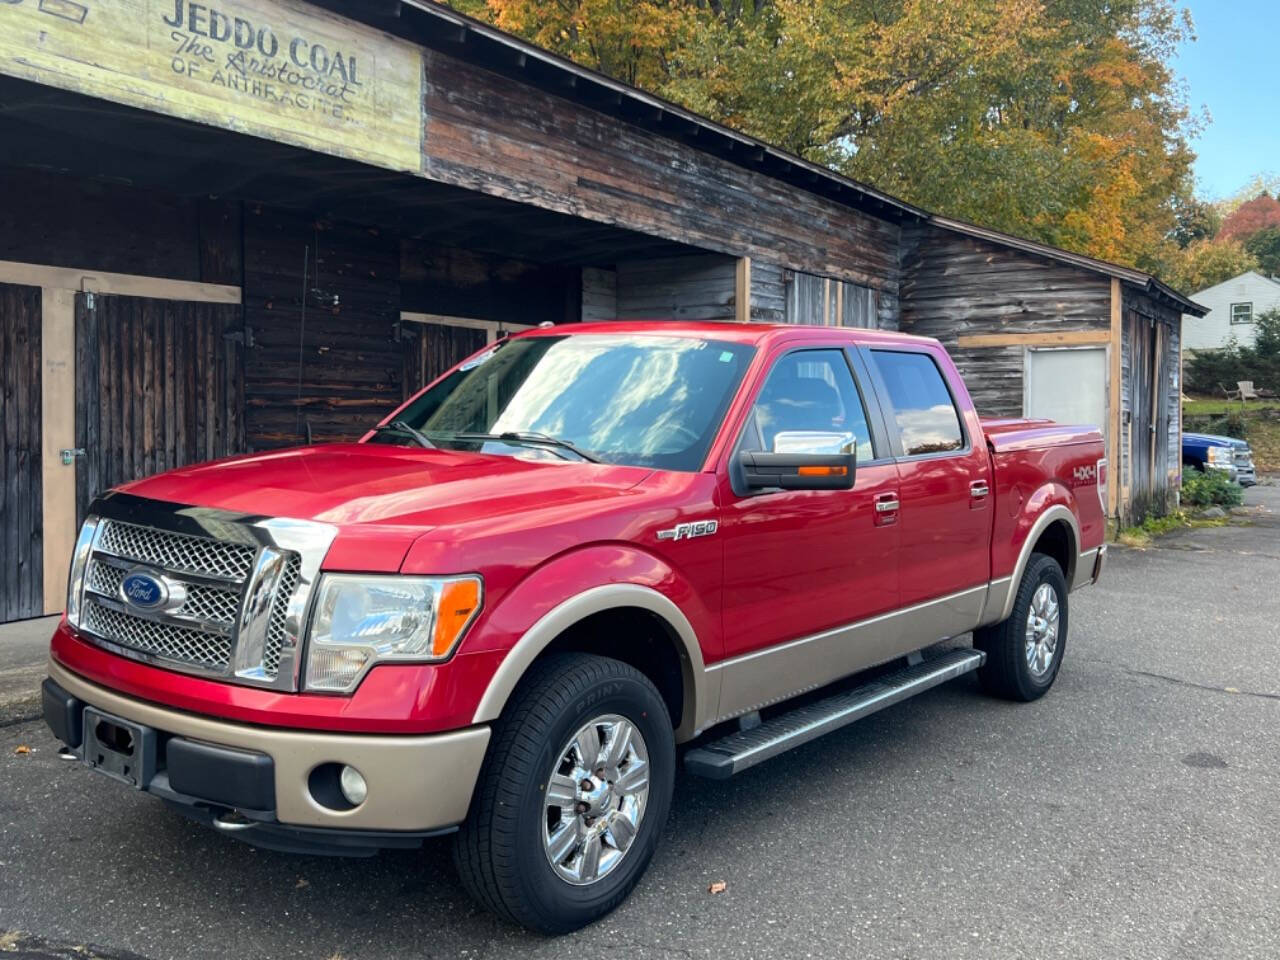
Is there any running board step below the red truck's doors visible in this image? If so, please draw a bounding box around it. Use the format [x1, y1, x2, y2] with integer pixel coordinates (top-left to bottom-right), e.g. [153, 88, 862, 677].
[685, 649, 987, 780]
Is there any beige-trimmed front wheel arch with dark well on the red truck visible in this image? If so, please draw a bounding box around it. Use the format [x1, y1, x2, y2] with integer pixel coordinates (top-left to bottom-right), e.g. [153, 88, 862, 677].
[472, 584, 718, 741]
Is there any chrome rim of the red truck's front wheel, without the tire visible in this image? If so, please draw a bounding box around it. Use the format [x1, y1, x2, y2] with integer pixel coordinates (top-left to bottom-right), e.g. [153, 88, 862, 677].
[543, 714, 649, 886]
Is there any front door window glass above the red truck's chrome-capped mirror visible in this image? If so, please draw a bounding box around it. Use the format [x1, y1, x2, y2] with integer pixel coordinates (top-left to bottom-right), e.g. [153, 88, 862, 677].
[741, 349, 874, 463]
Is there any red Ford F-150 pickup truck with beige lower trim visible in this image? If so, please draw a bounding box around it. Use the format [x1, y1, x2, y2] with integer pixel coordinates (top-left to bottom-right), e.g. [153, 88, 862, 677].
[44, 321, 1106, 932]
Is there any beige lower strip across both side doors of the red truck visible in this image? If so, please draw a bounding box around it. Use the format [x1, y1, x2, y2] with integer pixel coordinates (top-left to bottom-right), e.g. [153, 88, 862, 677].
[708, 584, 987, 721]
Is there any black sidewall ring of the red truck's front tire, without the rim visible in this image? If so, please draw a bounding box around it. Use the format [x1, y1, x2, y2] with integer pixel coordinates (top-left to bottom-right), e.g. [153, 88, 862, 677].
[513, 676, 676, 929]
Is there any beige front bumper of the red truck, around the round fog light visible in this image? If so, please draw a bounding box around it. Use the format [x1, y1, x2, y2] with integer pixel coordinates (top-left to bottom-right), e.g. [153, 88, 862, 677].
[49, 660, 489, 831]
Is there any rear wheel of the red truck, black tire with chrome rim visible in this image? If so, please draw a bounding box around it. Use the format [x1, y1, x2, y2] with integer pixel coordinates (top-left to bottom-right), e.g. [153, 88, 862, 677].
[973, 553, 1068, 701]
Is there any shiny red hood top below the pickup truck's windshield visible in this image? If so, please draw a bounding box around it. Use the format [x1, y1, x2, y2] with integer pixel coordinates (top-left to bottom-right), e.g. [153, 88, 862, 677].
[120, 443, 652, 535]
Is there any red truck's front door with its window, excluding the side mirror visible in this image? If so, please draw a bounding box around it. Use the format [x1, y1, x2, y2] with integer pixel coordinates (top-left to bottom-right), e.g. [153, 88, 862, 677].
[717, 347, 899, 717]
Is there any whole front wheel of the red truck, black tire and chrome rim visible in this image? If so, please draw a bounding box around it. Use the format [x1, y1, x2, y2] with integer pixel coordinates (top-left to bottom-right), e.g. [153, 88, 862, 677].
[453, 653, 676, 933]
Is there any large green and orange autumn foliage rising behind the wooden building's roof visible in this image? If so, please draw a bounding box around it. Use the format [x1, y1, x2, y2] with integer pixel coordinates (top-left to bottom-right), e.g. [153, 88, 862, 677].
[454, 0, 1204, 284]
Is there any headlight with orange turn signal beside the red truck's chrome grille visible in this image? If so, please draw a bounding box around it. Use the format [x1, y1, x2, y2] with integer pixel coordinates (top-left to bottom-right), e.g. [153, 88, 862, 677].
[306, 573, 484, 694]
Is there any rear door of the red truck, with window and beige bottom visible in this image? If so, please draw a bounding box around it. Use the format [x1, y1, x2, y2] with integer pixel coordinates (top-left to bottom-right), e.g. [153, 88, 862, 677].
[864, 344, 993, 632]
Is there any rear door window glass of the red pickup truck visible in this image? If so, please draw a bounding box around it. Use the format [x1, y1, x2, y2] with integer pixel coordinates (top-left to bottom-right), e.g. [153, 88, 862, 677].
[872, 349, 964, 457]
